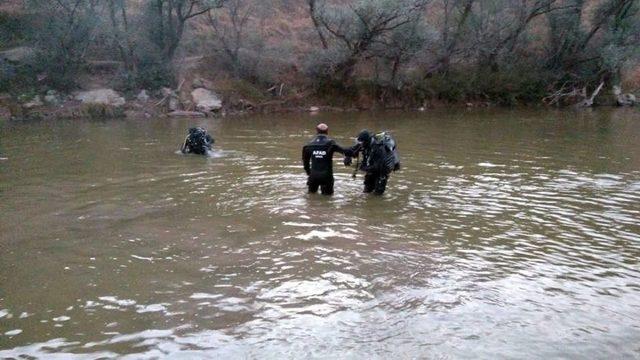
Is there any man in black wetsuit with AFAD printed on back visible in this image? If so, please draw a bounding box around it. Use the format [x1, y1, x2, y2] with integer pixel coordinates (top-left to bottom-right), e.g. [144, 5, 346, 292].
[302, 124, 344, 195]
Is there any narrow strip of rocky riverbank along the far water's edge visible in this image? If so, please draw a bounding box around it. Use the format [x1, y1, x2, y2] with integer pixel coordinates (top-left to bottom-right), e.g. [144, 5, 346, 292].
[0, 79, 636, 121]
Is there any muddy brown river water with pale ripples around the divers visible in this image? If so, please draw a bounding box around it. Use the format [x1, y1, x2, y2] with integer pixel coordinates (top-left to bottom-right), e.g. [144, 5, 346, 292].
[0, 110, 640, 359]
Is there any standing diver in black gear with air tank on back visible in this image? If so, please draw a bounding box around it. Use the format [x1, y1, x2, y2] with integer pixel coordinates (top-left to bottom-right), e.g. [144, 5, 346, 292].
[344, 130, 400, 195]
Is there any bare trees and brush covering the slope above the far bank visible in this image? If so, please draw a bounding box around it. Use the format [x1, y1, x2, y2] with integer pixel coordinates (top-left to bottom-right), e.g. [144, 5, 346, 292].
[0, 0, 640, 118]
